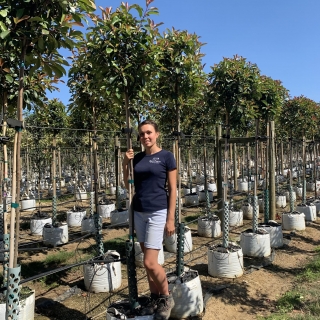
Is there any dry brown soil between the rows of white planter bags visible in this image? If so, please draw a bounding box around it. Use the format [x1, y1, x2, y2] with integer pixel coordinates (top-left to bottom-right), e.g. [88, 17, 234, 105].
[3, 190, 320, 320]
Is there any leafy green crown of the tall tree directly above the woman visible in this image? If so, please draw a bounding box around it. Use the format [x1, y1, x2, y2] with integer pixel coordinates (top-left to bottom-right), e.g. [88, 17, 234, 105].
[86, 1, 158, 124]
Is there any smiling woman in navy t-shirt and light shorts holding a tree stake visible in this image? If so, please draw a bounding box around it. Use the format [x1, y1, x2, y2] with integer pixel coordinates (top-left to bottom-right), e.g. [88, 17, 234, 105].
[123, 120, 177, 320]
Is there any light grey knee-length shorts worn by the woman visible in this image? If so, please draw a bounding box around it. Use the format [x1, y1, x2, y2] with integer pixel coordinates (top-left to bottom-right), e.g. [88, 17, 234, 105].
[134, 209, 168, 250]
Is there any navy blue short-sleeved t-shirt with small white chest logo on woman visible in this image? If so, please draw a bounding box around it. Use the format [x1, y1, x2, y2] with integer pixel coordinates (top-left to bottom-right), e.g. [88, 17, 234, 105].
[133, 150, 177, 212]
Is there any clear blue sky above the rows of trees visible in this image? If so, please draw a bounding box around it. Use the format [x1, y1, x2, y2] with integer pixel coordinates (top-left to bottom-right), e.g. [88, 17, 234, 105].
[48, 0, 320, 105]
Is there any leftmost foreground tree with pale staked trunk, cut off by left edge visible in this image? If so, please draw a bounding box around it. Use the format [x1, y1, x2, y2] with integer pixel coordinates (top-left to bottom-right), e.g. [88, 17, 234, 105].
[0, 0, 94, 306]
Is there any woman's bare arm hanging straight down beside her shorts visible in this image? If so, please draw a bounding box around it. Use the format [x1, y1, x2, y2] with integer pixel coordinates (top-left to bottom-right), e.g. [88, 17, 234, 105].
[165, 169, 177, 236]
